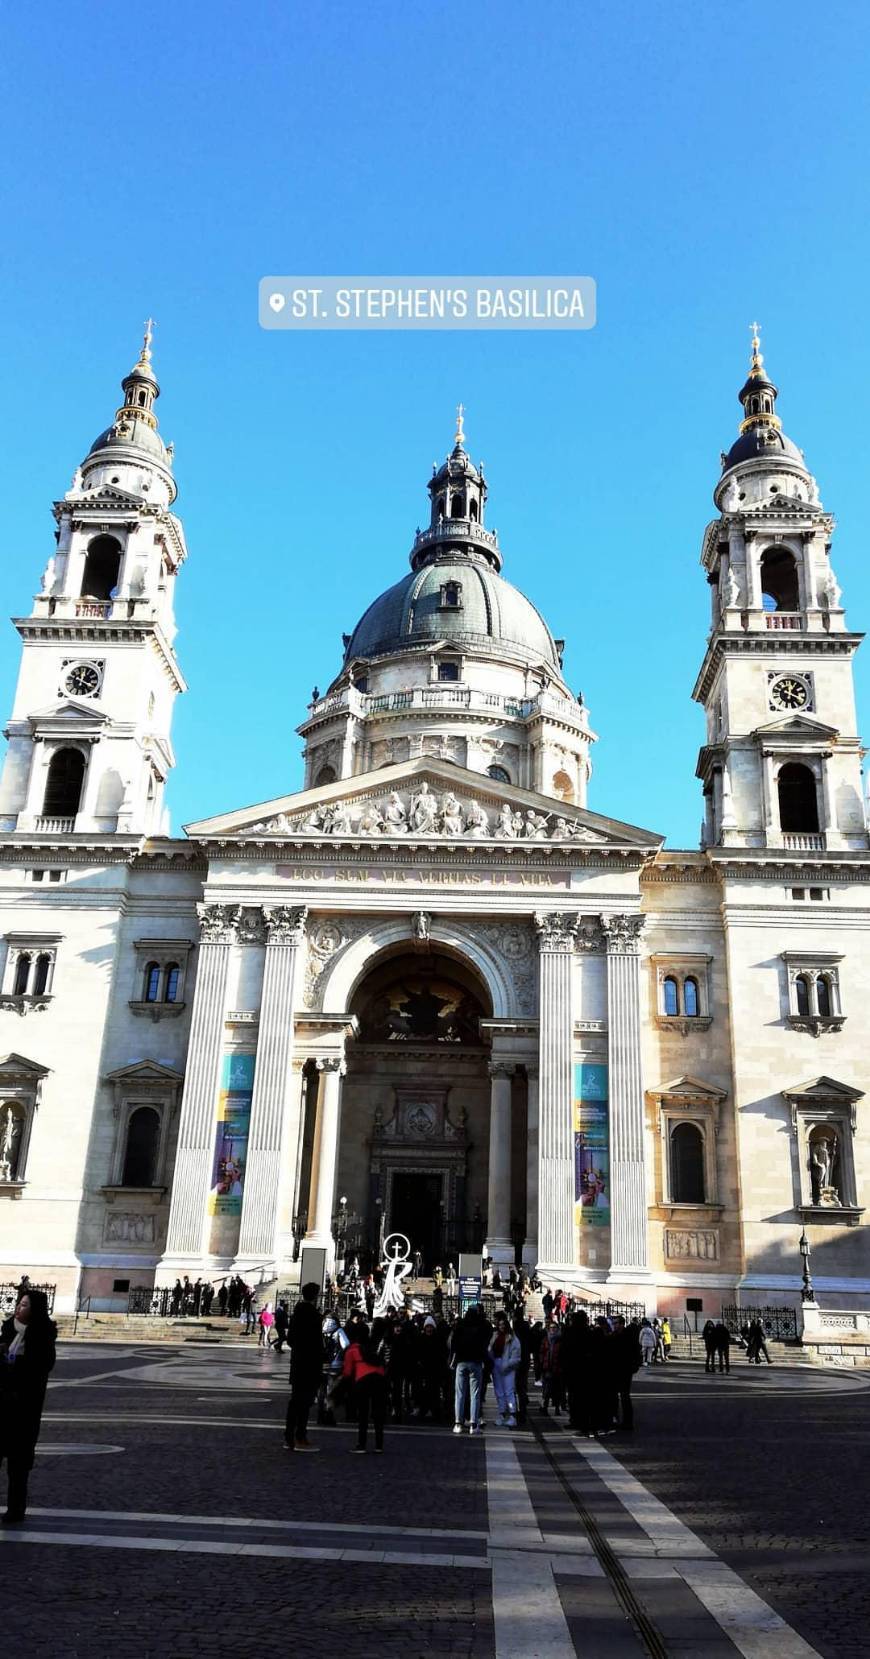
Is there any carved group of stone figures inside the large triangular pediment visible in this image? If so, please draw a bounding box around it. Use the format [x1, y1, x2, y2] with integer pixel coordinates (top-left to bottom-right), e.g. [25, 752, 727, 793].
[241, 780, 606, 846]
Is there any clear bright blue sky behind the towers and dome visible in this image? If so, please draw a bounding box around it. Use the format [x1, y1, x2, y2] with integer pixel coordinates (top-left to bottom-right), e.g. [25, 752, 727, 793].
[0, 0, 870, 846]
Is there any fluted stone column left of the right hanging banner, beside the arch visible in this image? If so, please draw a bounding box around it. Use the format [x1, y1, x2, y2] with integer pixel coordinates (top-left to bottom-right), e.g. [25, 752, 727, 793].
[535, 911, 578, 1269]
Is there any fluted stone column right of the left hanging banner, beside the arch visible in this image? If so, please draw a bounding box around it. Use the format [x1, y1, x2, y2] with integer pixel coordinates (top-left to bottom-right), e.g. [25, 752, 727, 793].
[239, 904, 307, 1266]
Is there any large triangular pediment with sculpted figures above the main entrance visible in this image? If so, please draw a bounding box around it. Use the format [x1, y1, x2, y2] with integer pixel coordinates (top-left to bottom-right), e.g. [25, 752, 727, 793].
[184, 757, 662, 851]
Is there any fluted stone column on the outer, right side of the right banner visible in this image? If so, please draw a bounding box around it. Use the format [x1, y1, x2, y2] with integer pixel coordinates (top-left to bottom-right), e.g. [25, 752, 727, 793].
[601, 916, 649, 1279]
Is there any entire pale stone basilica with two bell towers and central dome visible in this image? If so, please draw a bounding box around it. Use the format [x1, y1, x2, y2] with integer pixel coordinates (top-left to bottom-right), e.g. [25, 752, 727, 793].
[0, 333, 870, 1317]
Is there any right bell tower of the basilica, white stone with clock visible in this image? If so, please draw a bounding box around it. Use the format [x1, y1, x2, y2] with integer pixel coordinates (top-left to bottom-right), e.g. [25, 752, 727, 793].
[692, 324, 868, 853]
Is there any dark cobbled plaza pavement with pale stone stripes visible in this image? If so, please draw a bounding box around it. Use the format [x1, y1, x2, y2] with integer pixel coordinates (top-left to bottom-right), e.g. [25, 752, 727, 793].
[0, 1344, 870, 1659]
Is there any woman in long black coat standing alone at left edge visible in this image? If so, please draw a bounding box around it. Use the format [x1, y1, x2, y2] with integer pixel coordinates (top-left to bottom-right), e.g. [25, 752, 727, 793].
[0, 1291, 58, 1526]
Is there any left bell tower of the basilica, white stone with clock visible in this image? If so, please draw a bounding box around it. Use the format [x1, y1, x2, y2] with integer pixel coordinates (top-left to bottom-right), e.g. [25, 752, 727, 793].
[0, 322, 188, 836]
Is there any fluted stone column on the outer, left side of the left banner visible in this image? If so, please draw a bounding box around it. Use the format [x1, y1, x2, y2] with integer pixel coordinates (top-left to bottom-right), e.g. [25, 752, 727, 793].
[161, 904, 241, 1271]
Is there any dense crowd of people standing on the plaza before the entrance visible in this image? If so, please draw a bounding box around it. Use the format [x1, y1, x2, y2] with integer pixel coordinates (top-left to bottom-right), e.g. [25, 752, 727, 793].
[274, 1284, 650, 1452]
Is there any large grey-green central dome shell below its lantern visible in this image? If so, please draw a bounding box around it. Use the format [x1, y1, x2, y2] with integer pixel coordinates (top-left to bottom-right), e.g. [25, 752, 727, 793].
[345, 554, 561, 672]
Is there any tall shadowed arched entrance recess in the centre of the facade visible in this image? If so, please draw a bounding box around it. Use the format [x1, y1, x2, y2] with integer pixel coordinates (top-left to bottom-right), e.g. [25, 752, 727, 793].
[337, 944, 491, 1272]
